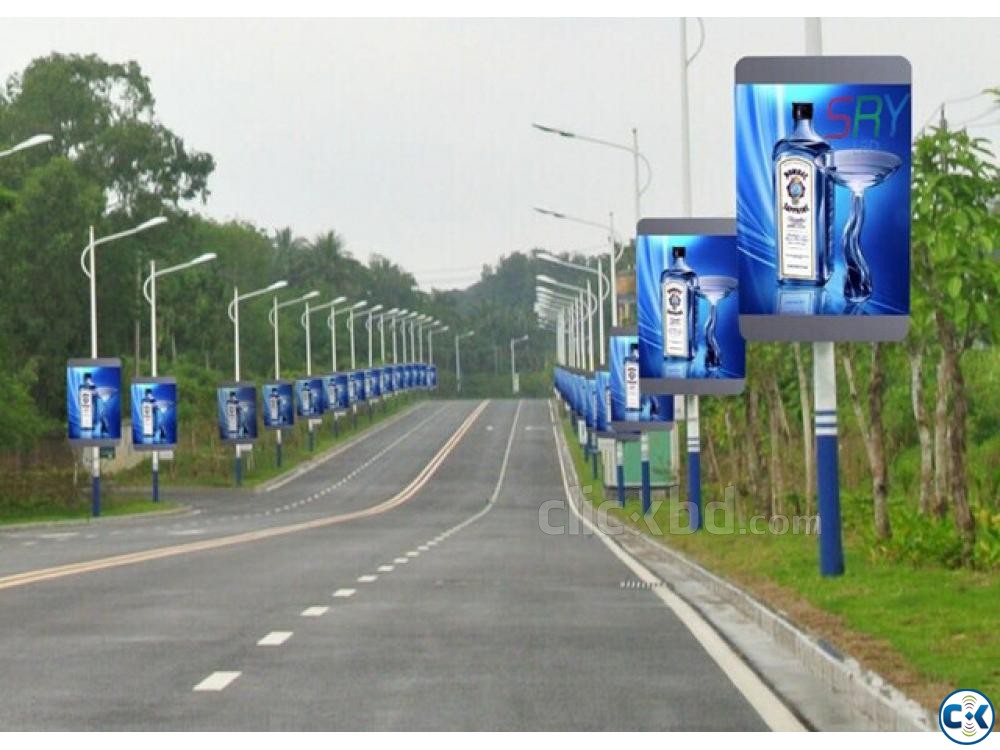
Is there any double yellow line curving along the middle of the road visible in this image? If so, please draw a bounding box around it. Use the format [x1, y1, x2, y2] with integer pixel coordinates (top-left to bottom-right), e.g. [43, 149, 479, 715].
[0, 401, 489, 590]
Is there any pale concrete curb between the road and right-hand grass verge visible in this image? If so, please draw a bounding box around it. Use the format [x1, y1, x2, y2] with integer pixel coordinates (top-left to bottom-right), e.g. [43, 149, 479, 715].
[557, 412, 937, 732]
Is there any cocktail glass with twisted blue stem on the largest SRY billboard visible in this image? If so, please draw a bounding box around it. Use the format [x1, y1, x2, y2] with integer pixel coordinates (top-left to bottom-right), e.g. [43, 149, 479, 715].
[816, 148, 903, 302]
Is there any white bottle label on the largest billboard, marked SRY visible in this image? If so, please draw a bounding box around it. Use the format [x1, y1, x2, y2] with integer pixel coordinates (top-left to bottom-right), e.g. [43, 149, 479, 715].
[775, 156, 816, 280]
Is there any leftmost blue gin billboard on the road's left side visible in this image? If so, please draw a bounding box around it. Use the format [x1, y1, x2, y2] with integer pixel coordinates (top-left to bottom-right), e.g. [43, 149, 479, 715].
[66, 358, 122, 446]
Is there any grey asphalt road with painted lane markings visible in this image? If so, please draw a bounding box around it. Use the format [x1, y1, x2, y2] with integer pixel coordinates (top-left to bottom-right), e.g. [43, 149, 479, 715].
[0, 401, 780, 730]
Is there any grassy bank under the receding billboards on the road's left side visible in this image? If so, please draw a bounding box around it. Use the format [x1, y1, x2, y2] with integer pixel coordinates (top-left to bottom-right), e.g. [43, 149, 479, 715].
[113, 394, 418, 494]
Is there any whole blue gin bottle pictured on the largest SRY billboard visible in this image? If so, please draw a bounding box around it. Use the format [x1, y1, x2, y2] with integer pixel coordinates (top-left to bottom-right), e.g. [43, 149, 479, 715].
[771, 102, 833, 286]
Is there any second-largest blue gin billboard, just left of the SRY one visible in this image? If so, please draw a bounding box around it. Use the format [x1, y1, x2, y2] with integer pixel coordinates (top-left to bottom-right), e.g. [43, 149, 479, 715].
[635, 219, 746, 394]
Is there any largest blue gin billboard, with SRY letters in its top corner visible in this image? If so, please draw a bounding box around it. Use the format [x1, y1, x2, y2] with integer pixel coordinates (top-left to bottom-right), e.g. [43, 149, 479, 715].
[735, 57, 911, 341]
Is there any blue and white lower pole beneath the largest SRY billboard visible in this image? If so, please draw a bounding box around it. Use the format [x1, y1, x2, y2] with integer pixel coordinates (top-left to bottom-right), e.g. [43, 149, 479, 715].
[813, 341, 844, 576]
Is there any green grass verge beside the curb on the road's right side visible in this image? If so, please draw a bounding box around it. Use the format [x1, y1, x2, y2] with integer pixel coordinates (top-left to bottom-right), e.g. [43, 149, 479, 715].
[563, 414, 1000, 711]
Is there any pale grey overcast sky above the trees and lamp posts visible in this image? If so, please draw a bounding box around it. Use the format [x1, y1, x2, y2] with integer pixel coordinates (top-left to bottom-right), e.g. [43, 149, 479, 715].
[0, 19, 1000, 288]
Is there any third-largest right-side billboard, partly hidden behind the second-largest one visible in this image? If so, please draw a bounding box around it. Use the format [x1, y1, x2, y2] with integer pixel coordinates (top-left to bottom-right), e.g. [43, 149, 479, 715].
[608, 328, 674, 432]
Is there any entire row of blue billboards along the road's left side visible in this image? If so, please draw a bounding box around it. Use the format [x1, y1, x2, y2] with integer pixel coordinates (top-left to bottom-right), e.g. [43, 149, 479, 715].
[66, 358, 437, 451]
